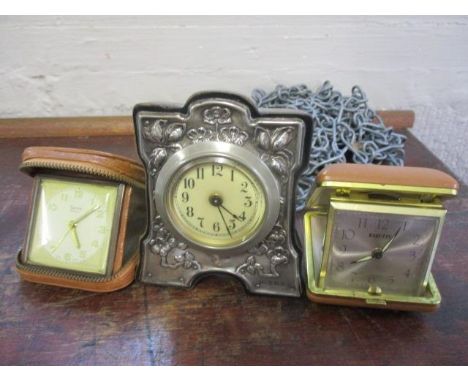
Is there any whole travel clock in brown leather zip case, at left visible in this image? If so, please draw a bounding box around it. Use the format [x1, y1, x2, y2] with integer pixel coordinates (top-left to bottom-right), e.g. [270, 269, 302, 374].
[17, 147, 145, 292]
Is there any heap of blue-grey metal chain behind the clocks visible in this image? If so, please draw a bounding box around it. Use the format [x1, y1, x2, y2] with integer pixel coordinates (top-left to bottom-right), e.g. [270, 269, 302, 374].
[252, 81, 406, 211]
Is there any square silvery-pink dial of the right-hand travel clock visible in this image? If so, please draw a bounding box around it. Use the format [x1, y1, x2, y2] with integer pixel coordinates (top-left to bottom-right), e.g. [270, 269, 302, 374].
[324, 210, 439, 295]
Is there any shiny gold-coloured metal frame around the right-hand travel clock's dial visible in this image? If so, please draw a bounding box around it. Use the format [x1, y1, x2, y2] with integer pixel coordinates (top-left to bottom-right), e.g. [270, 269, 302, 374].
[303, 169, 457, 311]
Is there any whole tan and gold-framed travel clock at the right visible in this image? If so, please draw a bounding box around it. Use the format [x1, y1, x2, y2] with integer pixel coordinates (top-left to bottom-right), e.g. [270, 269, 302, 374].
[304, 164, 458, 311]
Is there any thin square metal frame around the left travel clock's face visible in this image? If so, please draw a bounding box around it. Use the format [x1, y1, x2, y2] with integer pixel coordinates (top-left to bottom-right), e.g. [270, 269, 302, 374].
[21, 174, 128, 277]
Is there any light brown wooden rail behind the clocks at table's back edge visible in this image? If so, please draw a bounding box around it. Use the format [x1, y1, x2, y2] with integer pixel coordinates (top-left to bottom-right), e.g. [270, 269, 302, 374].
[0, 110, 414, 138]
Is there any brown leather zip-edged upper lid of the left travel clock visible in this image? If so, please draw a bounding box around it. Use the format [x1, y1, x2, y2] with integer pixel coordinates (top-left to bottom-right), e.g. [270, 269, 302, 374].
[20, 146, 145, 187]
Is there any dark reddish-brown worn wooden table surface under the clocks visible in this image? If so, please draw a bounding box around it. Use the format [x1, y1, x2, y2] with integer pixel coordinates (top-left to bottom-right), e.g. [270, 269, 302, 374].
[0, 133, 468, 365]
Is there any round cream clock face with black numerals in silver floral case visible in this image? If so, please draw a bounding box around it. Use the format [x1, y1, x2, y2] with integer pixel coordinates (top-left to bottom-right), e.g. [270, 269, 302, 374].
[166, 158, 266, 248]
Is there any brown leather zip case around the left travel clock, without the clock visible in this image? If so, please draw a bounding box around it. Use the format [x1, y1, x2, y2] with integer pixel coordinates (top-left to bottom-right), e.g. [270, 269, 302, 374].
[16, 147, 146, 292]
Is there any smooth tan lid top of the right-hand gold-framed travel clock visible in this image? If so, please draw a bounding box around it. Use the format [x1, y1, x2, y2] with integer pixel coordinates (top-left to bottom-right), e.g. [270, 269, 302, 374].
[317, 163, 458, 190]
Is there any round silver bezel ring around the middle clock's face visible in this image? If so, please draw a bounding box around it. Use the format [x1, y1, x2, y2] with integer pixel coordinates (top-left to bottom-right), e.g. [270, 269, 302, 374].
[153, 142, 281, 255]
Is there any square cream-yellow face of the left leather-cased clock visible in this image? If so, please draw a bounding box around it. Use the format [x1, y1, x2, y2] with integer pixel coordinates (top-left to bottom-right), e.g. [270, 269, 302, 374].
[27, 178, 119, 274]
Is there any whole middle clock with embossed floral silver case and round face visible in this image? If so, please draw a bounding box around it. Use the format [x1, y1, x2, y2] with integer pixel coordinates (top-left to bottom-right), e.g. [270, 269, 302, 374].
[133, 92, 312, 296]
